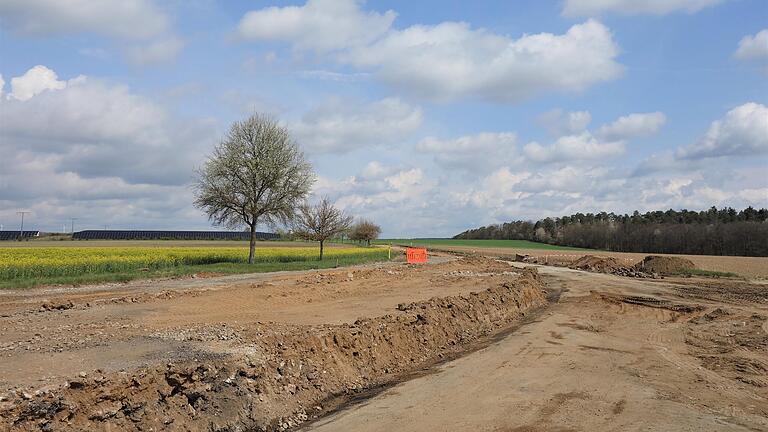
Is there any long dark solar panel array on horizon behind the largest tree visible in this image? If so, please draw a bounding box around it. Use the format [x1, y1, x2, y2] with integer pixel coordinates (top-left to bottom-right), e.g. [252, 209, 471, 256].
[72, 230, 280, 240]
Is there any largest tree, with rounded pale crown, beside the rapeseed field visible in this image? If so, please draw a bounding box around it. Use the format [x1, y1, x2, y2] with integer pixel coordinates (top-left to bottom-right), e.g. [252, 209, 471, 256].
[194, 114, 315, 264]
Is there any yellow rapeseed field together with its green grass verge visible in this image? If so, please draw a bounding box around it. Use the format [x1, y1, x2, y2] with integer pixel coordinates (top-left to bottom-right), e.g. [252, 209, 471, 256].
[0, 241, 388, 288]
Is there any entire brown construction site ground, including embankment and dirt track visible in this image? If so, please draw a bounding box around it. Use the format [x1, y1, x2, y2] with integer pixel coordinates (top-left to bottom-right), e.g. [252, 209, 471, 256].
[0, 250, 768, 432]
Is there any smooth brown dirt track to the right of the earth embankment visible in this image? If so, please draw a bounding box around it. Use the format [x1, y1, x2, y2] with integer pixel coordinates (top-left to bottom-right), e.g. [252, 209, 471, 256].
[305, 267, 768, 432]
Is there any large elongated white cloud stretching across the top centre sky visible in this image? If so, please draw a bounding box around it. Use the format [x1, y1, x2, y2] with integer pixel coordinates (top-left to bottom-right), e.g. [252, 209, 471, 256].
[238, 0, 623, 102]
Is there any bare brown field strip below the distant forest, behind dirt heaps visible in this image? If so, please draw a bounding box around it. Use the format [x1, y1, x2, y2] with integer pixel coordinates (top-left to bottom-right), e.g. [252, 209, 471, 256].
[424, 245, 768, 281]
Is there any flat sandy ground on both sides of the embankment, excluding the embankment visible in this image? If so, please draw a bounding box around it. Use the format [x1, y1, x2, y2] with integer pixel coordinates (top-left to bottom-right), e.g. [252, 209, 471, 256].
[0, 250, 768, 432]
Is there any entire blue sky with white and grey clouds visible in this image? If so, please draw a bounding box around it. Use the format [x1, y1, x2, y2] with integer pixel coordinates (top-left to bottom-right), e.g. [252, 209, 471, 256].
[0, 0, 768, 236]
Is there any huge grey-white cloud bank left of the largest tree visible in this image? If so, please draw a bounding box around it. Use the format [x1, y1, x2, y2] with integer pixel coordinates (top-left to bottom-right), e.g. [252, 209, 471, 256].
[0, 66, 219, 230]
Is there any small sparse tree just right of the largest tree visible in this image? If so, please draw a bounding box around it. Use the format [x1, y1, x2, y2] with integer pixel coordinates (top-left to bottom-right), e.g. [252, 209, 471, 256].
[293, 197, 352, 260]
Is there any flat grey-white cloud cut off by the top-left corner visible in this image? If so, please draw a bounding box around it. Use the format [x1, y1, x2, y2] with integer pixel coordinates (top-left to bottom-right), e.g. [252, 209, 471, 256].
[0, 0, 169, 40]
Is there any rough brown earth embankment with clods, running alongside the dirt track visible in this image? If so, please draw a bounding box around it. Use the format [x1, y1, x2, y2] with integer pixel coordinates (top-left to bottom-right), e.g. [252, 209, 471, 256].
[0, 269, 546, 431]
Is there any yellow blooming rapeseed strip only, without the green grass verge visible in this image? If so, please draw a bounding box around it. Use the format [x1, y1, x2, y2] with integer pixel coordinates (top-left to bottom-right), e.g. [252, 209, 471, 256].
[0, 247, 387, 280]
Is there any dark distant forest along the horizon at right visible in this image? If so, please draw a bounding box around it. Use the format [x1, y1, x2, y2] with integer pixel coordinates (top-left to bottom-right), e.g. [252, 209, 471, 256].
[454, 207, 768, 256]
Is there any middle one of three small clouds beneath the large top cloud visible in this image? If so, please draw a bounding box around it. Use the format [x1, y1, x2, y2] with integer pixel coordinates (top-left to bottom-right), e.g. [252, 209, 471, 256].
[416, 132, 517, 171]
